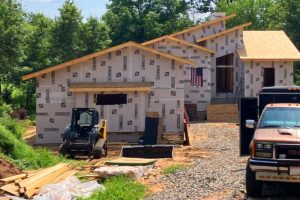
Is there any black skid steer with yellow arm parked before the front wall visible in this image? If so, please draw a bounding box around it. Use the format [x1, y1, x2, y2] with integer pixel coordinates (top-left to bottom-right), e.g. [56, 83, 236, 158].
[59, 108, 107, 159]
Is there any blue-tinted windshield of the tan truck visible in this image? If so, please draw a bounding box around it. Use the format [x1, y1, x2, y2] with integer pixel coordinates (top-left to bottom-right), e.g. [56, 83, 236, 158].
[259, 107, 300, 128]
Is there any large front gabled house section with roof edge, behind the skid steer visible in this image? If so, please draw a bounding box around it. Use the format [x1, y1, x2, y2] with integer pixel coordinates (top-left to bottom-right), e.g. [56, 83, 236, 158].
[23, 42, 195, 143]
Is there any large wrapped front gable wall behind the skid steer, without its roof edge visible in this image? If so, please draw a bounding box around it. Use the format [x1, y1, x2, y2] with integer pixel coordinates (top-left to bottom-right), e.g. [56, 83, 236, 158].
[36, 47, 184, 143]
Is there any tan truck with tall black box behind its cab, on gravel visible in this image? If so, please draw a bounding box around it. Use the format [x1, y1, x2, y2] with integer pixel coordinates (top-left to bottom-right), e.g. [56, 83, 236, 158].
[240, 86, 300, 197]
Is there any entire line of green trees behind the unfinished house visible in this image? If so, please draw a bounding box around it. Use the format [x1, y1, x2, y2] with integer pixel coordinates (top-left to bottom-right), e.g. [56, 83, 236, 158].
[0, 0, 300, 109]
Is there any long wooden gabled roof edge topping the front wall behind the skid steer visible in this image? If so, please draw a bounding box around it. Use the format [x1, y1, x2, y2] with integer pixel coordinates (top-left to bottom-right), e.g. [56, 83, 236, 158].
[22, 42, 196, 81]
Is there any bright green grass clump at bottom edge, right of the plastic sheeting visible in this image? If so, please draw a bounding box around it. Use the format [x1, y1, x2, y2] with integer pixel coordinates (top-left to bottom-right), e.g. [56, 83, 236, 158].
[79, 176, 146, 200]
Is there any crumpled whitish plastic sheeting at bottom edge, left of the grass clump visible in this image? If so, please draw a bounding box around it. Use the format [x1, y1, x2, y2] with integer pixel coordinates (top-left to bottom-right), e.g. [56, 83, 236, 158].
[33, 176, 105, 200]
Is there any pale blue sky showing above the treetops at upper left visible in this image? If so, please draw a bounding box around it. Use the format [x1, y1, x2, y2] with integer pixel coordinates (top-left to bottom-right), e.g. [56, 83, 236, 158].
[21, 0, 109, 18]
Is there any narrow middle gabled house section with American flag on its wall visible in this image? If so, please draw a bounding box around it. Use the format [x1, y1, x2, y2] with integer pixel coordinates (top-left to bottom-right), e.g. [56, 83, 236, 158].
[143, 36, 214, 121]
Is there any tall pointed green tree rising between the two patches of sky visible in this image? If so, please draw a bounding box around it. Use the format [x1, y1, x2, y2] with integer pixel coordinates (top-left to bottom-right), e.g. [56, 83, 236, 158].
[52, 0, 84, 63]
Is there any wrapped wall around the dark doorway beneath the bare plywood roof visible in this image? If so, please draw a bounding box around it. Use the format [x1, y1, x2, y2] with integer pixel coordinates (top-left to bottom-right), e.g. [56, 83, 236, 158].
[242, 60, 293, 97]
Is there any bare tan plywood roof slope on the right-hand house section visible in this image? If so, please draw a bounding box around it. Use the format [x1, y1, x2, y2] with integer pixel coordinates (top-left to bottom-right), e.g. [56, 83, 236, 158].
[237, 31, 300, 61]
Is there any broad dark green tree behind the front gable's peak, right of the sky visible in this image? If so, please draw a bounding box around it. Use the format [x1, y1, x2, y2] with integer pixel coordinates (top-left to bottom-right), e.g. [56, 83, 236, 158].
[103, 0, 192, 45]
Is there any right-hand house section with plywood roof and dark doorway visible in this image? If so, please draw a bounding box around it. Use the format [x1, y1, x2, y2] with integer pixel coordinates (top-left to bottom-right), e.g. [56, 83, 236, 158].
[237, 31, 300, 97]
